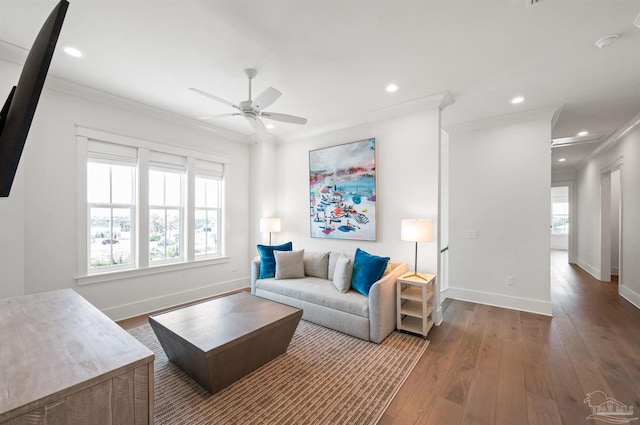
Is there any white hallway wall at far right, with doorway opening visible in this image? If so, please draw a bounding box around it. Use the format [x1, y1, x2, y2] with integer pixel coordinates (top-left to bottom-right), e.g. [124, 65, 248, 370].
[577, 129, 640, 307]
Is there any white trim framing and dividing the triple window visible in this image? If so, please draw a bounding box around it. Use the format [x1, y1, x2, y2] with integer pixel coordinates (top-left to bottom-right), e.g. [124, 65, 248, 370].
[75, 126, 231, 285]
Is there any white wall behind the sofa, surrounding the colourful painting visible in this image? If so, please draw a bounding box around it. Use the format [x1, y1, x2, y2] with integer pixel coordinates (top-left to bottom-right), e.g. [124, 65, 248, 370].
[274, 108, 440, 273]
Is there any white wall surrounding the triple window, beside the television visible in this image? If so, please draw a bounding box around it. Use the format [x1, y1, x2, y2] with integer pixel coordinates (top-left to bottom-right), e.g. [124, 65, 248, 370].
[0, 61, 249, 319]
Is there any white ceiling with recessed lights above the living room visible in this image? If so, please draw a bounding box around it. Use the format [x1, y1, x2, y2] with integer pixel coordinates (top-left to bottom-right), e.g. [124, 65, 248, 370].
[0, 0, 640, 166]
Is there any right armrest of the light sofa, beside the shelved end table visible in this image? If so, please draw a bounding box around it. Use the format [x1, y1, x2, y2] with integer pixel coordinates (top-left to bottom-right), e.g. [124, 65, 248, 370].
[369, 263, 409, 344]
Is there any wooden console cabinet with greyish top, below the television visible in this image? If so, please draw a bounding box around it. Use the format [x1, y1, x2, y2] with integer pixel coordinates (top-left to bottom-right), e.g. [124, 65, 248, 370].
[0, 289, 154, 425]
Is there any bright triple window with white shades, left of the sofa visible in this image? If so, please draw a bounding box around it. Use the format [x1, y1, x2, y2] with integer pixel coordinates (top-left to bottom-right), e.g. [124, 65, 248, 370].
[78, 129, 224, 282]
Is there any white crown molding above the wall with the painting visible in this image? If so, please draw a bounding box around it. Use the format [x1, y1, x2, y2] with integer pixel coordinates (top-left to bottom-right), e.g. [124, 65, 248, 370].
[278, 91, 454, 143]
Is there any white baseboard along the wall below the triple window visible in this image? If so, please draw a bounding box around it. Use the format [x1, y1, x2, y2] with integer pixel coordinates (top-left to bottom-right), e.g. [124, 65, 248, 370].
[102, 278, 250, 321]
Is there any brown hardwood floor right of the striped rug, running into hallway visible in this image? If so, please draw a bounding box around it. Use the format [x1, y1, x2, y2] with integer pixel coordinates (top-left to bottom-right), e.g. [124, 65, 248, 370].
[379, 251, 640, 425]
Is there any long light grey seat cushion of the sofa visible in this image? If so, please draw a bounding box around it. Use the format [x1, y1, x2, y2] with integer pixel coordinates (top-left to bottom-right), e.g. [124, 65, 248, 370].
[256, 276, 369, 318]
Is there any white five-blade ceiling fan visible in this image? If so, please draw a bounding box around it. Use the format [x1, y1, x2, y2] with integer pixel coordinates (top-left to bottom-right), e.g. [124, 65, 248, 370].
[189, 68, 307, 133]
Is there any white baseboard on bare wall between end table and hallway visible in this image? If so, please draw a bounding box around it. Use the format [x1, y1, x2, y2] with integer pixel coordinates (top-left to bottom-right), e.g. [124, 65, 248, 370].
[441, 287, 553, 316]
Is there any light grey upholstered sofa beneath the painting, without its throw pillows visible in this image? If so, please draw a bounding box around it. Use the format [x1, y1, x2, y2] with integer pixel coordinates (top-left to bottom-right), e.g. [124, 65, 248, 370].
[251, 252, 407, 344]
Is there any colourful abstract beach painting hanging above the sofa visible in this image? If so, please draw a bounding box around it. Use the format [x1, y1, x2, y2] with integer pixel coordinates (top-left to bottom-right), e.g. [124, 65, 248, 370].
[309, 139, 377, 241]
